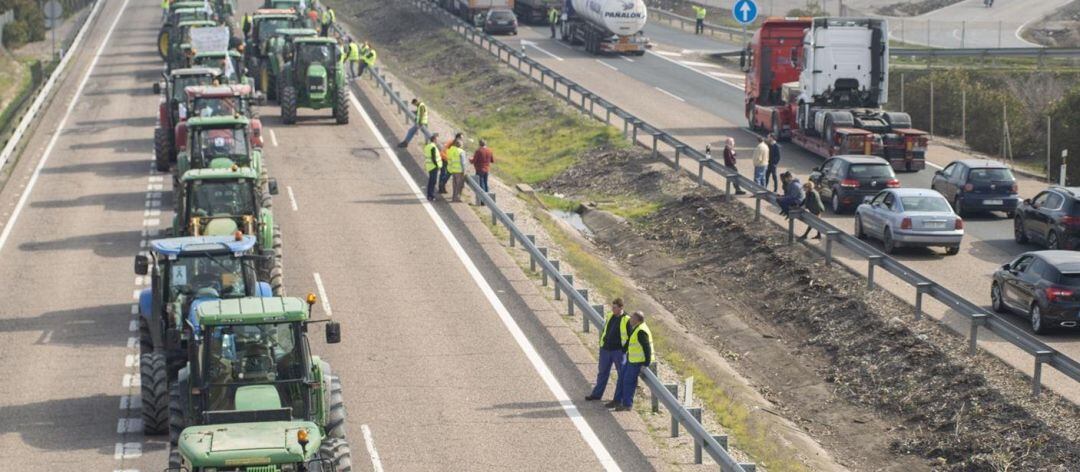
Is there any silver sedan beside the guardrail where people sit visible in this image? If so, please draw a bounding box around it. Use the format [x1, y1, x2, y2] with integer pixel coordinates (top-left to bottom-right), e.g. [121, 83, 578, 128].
[855, 189, 963, 256]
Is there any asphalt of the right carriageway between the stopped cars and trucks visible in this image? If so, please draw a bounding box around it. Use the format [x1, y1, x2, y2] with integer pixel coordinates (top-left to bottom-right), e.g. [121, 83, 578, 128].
[490, 19, 1080, 399]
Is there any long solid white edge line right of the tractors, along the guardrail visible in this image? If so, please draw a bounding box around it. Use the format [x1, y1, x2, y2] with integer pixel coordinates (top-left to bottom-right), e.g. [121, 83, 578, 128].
[349, 91, 621, 471]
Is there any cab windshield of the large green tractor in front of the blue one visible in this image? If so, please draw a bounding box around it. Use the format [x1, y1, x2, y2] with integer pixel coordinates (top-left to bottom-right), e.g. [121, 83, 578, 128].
[203, 323, 303, 410]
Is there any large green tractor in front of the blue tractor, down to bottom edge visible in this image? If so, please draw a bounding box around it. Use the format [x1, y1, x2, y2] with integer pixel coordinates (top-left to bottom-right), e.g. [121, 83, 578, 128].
[168, 295, 352, 472]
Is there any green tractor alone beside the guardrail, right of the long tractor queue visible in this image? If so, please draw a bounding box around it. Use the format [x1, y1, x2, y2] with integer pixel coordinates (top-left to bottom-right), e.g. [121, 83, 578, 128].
[279, 38, 349, 124]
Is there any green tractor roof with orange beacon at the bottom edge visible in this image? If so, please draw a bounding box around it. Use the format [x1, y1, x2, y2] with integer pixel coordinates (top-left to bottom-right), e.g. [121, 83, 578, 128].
[177, 421, 323, 470]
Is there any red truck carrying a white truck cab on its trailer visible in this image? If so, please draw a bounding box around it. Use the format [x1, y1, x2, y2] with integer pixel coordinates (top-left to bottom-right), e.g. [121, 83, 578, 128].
[742, 17, 929, 172]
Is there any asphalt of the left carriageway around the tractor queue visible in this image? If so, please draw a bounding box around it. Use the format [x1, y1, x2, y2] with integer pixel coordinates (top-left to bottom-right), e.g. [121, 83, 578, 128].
[0, 0, 651, 471]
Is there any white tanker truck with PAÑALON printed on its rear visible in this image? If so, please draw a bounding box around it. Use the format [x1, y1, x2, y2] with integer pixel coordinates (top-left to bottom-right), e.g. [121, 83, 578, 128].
[562, 0, 649, 56]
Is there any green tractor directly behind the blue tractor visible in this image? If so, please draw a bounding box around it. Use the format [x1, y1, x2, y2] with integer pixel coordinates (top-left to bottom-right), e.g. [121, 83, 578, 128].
[172, 165, 282, 280]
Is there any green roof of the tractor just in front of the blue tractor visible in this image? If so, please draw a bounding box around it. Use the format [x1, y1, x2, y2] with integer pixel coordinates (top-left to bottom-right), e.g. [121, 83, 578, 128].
[197, 297, 308, 326]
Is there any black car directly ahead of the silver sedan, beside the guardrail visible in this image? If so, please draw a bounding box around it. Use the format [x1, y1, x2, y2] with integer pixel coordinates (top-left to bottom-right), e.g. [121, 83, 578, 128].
[810, 156, 900, 214]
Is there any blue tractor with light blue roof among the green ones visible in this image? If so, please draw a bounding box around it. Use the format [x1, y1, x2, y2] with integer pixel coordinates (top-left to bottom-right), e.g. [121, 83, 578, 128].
[135, 235, 283, 434]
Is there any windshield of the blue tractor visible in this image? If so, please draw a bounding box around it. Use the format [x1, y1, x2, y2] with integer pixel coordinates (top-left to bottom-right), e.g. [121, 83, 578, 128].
[168, 254, 247, 299]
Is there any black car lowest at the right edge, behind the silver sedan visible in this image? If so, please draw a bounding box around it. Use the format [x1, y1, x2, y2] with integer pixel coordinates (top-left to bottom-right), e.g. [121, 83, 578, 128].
[990, 251, 1080, 334]
